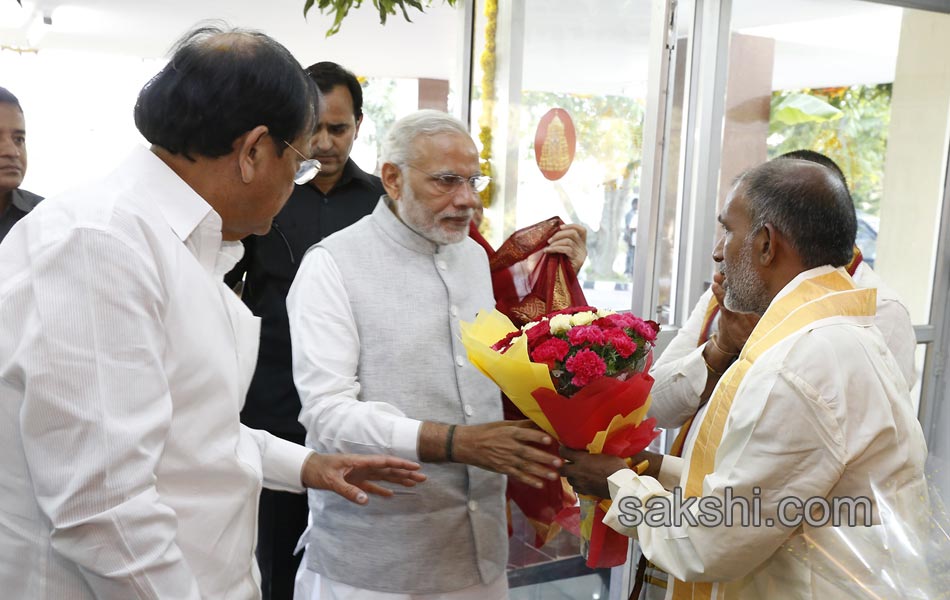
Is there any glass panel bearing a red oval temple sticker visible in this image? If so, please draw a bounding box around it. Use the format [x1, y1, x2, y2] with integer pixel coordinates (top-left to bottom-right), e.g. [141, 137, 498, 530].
[472, 0, 653, 309]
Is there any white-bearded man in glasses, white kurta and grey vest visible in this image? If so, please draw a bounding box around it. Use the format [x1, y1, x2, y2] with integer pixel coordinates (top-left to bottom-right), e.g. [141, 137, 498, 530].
[287, 110, 561, 600]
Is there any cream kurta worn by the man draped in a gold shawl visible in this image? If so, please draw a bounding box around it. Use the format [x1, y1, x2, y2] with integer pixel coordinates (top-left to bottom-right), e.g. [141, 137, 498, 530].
[604, 267, 927, 600]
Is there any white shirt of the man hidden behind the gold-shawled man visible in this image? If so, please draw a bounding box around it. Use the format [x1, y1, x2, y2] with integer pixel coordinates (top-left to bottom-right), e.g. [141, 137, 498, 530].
[649, 262, 917, 428]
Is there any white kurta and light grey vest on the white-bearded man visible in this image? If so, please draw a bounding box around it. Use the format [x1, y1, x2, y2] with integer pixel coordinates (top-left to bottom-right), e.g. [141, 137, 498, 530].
[287, 199, 507, 600]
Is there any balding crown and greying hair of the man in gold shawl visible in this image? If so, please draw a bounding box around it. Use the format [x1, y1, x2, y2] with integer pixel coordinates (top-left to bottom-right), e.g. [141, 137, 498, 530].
[737, 158, 857, 269]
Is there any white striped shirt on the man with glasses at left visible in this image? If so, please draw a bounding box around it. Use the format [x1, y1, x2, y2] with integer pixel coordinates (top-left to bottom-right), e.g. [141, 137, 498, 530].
[0, 148, 309, 600]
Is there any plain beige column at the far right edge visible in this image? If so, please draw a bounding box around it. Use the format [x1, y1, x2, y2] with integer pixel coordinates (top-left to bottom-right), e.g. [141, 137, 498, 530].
[875, 10, 950, 323]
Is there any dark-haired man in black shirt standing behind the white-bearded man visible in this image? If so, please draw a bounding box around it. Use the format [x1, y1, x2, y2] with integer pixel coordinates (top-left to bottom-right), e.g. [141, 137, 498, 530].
[225, 62, 384, 600]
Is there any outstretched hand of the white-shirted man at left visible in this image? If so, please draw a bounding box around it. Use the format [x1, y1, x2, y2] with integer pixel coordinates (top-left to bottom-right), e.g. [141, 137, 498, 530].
[300, 452, 426, 504]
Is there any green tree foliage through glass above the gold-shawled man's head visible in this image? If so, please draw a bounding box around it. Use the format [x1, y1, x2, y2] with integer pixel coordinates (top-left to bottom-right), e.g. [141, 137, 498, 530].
[769, 83, 892, 216]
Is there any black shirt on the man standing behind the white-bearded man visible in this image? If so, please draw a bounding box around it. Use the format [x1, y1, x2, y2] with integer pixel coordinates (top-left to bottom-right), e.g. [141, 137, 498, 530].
[225, 159, 384, 437]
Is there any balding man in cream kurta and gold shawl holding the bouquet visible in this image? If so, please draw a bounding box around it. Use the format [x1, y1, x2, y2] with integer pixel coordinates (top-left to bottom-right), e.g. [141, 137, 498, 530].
[562, 160, 927, 600]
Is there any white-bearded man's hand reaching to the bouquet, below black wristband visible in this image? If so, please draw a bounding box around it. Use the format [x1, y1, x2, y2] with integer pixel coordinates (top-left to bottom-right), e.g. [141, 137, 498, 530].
[452, 420, 563, 488]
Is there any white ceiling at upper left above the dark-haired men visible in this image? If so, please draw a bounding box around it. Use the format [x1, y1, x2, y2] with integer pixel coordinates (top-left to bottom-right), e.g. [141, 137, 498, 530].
[0, 0, 460, 78]
